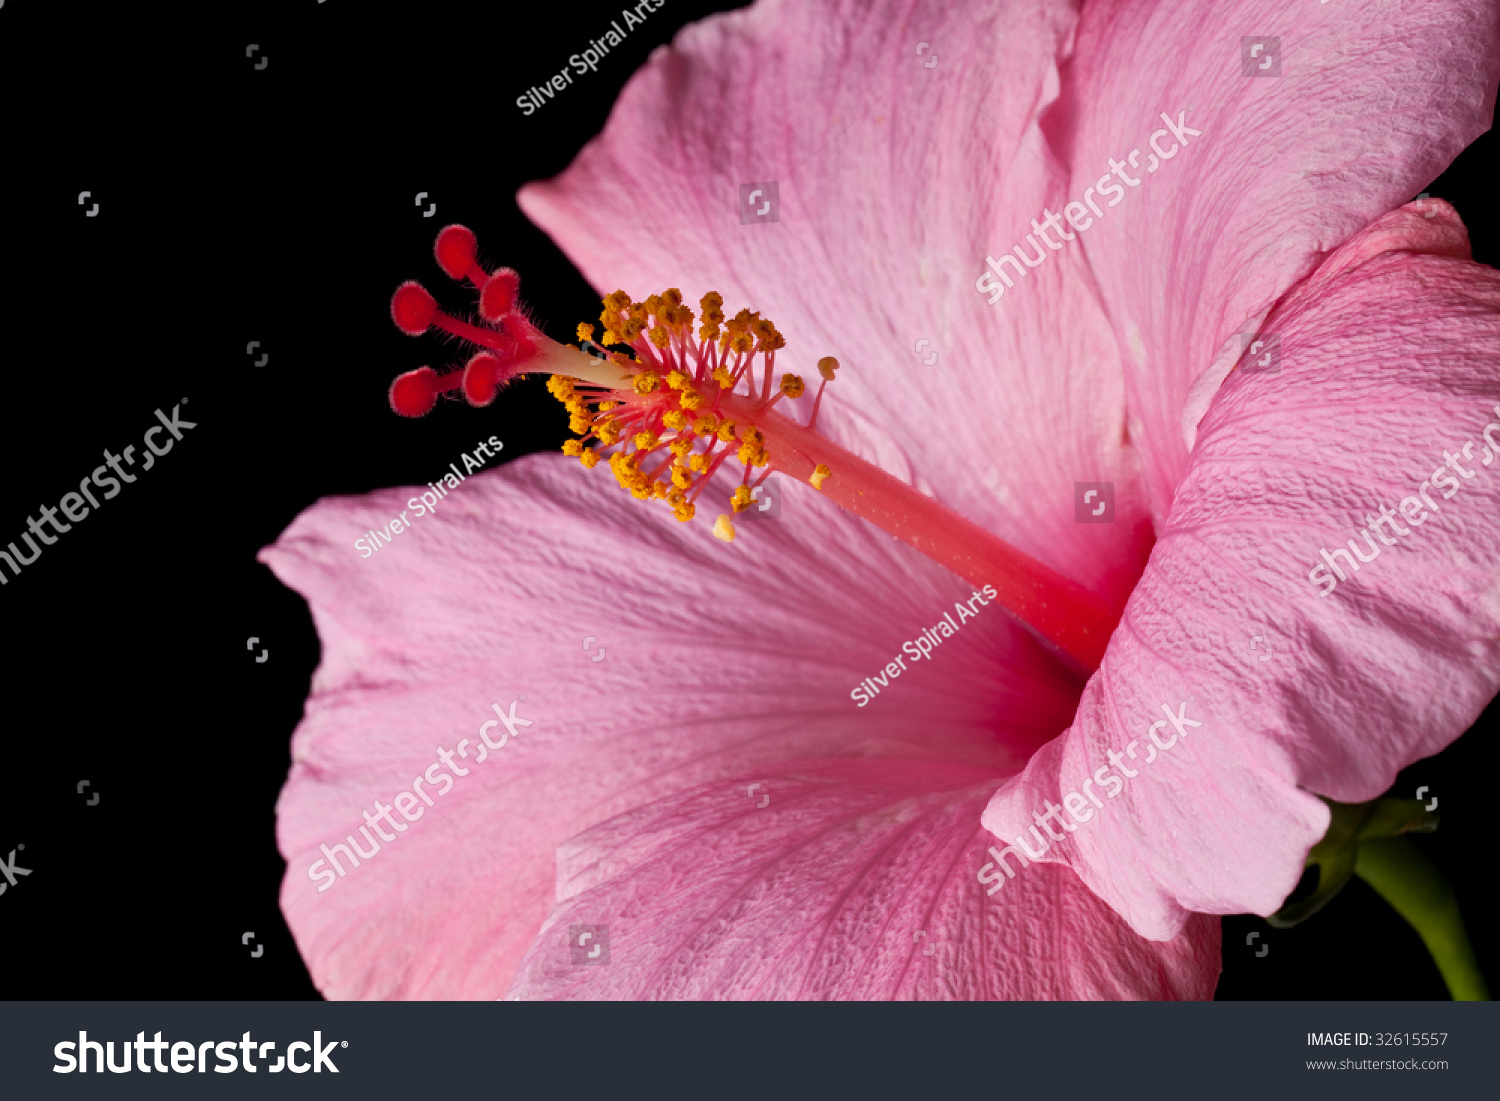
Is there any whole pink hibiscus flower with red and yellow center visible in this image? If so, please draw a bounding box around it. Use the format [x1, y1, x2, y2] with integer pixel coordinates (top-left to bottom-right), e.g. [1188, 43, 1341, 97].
[263, 0, 1500, 998]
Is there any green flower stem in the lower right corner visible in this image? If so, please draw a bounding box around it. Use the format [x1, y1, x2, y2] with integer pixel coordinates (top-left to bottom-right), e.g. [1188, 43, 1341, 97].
[1355, 837, 1490, 1002]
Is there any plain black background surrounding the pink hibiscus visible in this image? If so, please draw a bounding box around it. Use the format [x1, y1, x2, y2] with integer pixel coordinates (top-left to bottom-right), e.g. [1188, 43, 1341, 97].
[0, 0, 1500, 999]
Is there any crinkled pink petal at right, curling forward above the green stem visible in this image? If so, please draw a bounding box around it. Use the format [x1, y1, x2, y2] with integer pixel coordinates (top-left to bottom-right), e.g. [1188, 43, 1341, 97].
[984, 204, 1500, 939]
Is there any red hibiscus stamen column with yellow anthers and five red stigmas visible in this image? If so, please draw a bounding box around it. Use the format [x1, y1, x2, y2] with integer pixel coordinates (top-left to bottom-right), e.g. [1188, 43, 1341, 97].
[381, 225, 1121, 672]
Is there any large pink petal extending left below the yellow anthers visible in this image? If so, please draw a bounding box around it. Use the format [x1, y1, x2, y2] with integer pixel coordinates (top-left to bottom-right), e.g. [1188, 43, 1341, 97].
[263, 456, 1079, 998]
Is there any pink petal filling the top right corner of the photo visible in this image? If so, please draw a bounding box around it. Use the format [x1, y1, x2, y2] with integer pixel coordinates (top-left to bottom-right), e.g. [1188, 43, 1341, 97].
[1068, 0, 1500, 528]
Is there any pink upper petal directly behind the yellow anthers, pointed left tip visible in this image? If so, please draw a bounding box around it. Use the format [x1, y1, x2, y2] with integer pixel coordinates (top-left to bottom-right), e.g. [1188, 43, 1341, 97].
[519, 0, 1151, 603]
